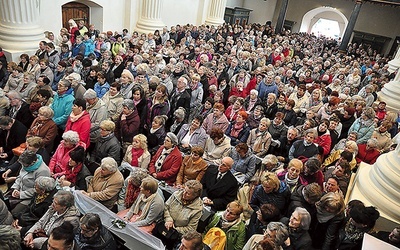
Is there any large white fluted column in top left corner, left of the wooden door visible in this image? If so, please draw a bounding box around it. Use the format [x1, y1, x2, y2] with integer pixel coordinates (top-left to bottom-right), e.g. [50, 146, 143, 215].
[0, 0, 44, 54]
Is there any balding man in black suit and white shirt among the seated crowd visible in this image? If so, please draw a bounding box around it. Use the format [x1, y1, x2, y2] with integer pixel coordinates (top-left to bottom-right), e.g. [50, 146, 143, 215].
[201, 157, 238, 211]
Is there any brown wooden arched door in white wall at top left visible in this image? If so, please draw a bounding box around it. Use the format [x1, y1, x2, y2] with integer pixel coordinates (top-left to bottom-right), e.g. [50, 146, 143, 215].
[62, 2, 90, 29]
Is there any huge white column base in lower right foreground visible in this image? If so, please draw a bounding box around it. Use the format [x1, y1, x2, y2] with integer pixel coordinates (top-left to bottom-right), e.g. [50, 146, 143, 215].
[346, 151, 400, 231]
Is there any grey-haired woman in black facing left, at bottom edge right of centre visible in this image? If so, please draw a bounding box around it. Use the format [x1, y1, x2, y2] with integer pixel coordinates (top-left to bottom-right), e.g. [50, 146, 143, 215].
[282, 207, 312, 250]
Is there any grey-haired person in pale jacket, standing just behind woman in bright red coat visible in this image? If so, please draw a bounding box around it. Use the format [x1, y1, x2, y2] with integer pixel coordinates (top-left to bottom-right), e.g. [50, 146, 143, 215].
[83, 89, 107, 145]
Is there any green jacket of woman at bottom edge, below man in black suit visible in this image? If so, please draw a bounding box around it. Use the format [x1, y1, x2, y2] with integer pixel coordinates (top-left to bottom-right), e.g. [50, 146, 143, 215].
[204, 212, 246, 250]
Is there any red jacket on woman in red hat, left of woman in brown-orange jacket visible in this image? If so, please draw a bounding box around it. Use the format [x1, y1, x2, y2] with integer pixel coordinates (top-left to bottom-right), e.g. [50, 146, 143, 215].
[149, 146, 182, 185]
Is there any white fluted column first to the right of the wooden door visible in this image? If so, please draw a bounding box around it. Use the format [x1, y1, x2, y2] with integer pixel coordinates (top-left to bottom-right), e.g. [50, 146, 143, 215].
[136, 0, 165, 33]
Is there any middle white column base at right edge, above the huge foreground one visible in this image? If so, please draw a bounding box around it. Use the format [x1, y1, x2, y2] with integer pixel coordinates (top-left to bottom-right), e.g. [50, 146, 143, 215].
[378, 80, 400, 112]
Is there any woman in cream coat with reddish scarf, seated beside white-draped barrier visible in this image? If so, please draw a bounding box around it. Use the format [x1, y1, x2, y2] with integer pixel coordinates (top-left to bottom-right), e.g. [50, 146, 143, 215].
[118, 177, 164, 233]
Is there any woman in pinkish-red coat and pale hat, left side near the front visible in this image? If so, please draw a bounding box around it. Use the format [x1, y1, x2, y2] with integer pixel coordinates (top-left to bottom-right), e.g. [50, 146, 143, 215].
[49, 131, 86, 178]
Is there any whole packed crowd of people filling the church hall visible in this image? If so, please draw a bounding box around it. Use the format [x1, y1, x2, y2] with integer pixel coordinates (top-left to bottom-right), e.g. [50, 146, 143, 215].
[0, 17, 400, 250]
